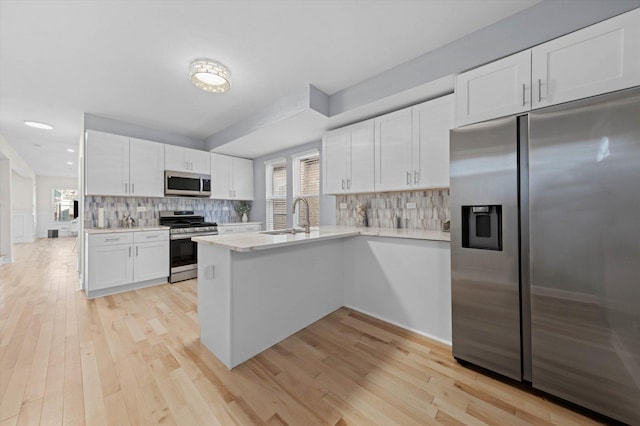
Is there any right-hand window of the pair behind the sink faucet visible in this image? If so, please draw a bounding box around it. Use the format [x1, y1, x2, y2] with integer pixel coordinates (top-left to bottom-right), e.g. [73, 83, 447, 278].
[292, 150, 320, 226]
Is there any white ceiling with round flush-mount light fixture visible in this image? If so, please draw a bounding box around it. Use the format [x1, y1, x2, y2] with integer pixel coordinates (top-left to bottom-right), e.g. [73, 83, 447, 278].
[0, 0, 540, 176]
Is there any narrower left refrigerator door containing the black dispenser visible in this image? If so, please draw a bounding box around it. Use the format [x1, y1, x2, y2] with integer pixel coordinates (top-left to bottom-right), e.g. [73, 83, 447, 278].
[450, 117, 522, 380]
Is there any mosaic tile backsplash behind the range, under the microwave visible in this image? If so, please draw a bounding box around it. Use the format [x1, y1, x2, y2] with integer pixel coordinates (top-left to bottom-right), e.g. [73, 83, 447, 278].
[84, 196, 250, 228]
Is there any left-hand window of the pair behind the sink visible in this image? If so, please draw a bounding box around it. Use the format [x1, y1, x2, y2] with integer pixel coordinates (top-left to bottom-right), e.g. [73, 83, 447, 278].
[265, 158, 287, 231]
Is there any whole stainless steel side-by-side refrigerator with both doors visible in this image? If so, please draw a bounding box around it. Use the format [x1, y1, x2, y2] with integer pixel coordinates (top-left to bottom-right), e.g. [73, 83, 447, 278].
[450, 87, 640, 424]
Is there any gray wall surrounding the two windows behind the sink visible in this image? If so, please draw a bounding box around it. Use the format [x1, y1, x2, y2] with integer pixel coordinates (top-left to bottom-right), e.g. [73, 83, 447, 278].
[249, 141, 336, 227]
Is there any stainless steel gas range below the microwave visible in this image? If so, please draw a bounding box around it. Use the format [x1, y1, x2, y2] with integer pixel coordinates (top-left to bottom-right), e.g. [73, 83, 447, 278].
[160, 210, 218, 283]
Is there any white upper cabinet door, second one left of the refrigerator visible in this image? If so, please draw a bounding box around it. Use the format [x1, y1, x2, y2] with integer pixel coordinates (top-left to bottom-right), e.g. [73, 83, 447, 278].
[374, 108, 413, 191]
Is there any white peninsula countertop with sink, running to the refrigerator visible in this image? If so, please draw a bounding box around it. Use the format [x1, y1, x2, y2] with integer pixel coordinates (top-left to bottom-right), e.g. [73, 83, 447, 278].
[192, 226, 451, 252]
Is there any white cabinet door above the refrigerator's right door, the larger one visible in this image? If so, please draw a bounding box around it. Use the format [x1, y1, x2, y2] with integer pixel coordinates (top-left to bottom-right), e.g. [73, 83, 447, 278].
[532, 9, 640, 108]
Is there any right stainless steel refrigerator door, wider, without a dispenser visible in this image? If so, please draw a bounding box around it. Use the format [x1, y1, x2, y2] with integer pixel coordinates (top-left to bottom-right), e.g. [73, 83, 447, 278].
[529, 88, 640, 424]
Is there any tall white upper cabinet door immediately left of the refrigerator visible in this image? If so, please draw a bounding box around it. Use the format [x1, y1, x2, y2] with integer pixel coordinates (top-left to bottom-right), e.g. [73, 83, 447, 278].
[412, 95, 455, 189]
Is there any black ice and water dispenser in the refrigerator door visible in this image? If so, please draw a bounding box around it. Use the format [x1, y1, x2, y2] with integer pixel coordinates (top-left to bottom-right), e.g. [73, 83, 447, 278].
[462, 205, 502, 251]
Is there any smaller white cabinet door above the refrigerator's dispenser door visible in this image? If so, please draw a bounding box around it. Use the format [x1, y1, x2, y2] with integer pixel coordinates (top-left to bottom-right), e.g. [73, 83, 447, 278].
[456, 50, 531, 126]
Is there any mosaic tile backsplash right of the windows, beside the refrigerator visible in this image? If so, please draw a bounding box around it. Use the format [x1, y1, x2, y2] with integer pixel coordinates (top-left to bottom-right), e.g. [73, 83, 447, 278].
[336, 189, 449, 231]
